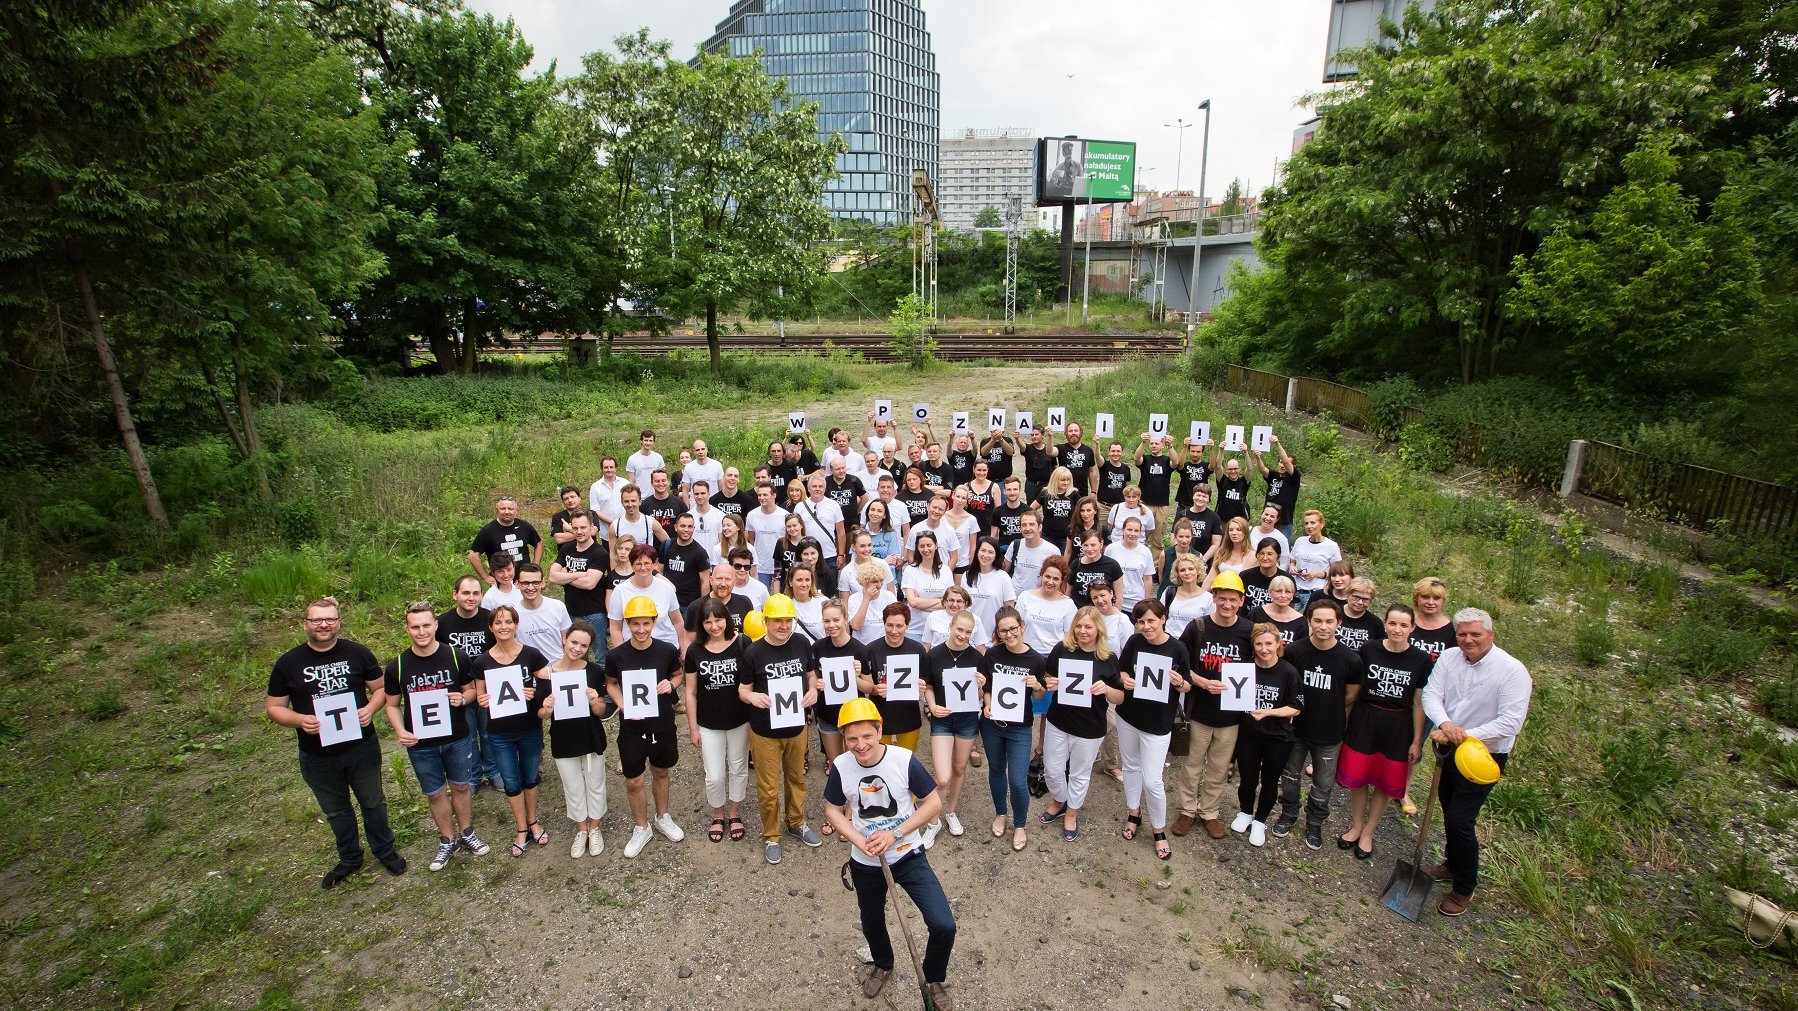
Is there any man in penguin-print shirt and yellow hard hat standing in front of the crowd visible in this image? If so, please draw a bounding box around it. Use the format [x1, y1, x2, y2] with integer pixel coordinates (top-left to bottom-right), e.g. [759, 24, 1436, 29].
[823, 698, 955, 1011]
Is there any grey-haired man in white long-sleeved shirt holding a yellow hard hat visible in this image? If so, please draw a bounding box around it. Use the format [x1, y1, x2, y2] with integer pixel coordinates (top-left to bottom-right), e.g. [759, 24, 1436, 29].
[1422, 608, 1532, 916]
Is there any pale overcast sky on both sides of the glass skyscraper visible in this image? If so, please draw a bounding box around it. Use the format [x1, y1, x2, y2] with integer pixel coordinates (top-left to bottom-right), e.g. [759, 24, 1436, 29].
[467, 0, 1331, 200]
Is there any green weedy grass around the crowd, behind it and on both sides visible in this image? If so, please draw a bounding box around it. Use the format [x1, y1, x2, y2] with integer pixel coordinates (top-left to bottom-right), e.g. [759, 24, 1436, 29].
[0, 362, 1798, 1009]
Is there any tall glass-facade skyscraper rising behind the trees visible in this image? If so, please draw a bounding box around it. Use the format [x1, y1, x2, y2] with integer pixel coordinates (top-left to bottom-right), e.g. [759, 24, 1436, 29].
[705, 0, 942, 225]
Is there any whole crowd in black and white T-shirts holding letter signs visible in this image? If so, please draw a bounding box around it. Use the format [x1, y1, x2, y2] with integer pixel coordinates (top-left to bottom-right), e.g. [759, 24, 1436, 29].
[268, 402, 1530, 1006]
